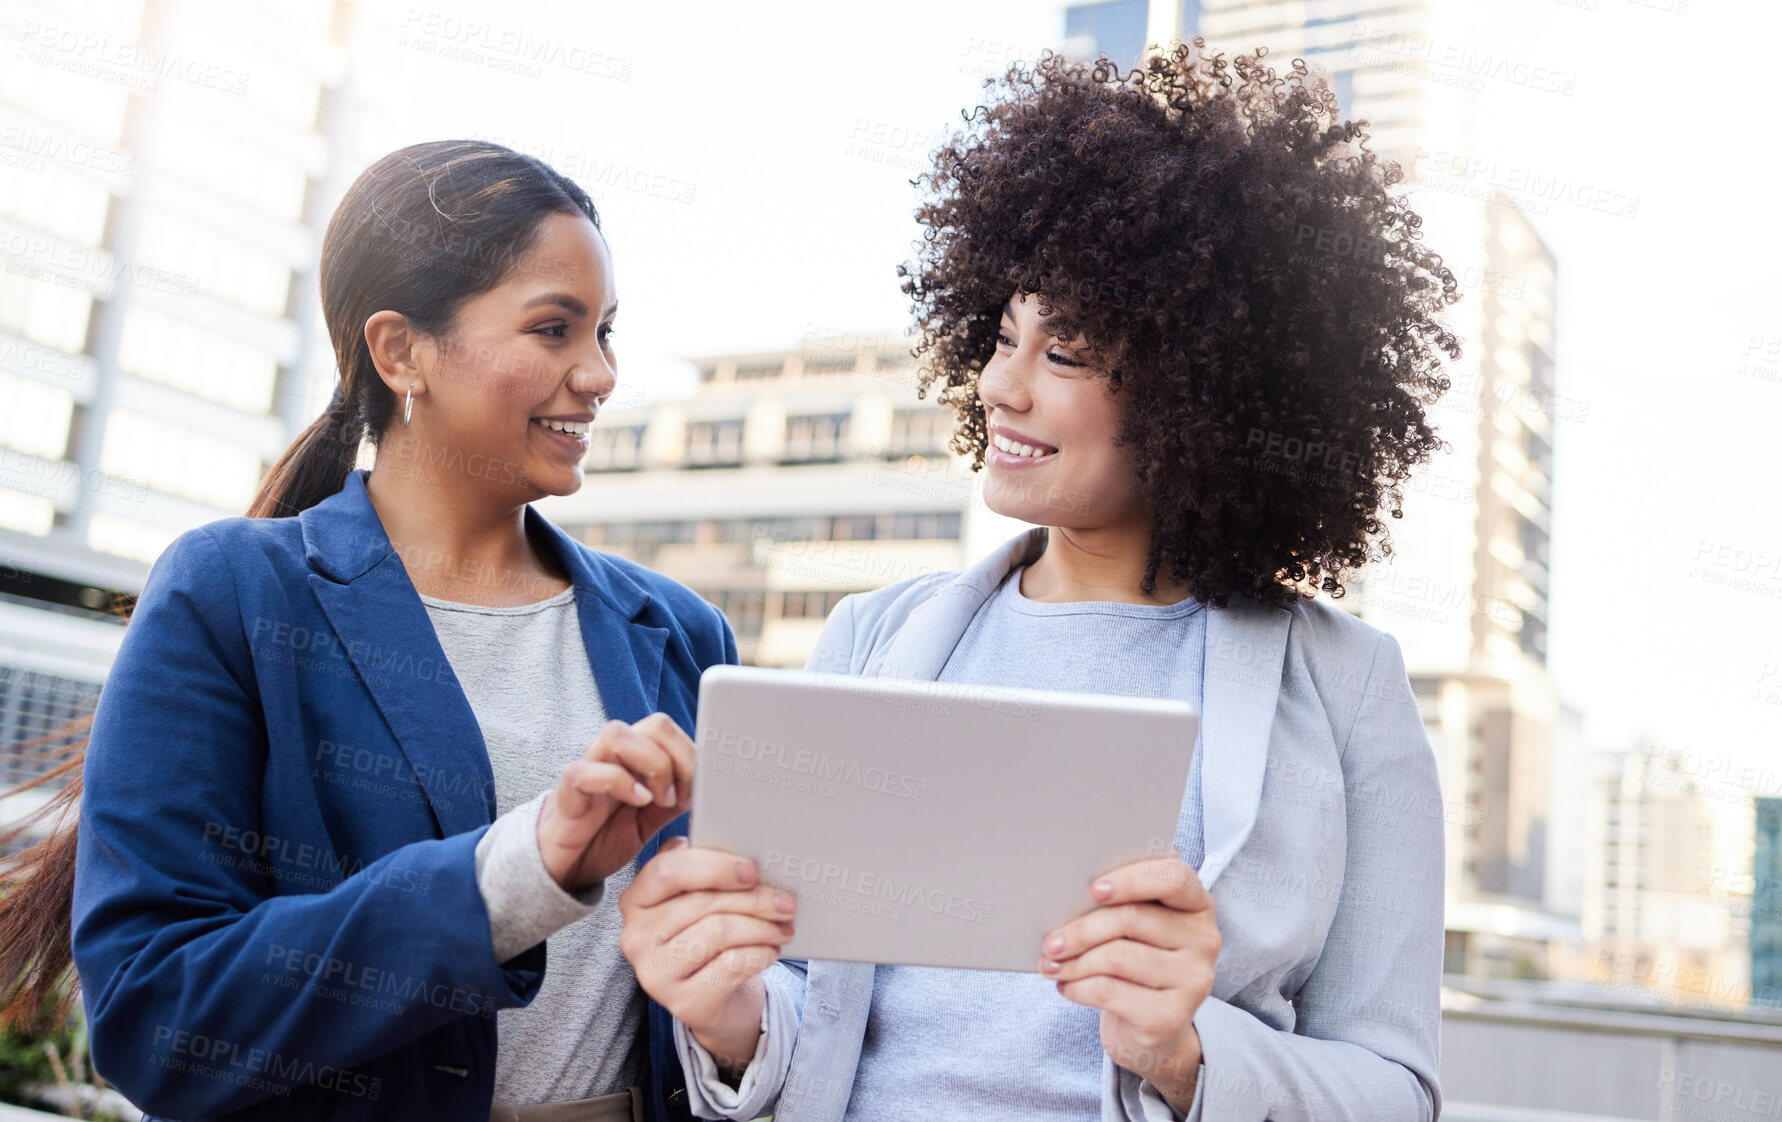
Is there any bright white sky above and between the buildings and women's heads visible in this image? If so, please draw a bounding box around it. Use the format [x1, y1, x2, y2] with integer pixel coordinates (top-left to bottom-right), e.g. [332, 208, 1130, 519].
[365, 0, 1782, 793]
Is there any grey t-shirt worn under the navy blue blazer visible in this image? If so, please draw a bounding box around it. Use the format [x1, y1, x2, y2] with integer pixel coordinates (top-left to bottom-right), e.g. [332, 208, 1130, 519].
[421, 589, 647, 1106]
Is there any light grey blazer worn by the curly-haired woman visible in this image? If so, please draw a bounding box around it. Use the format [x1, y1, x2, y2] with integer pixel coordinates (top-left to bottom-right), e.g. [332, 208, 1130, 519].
[675, 529, 1443, 1122]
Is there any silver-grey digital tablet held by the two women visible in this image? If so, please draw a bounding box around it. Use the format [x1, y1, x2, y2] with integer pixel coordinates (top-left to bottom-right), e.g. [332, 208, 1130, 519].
[690, 666, 1199, 972]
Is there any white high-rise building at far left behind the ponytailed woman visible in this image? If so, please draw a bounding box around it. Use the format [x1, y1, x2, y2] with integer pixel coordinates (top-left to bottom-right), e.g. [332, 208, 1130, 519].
[0, 0, 397, 817]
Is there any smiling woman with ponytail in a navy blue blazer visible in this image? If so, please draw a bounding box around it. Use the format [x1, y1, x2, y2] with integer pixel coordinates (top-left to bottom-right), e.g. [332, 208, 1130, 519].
[5, 141, 766, 1120]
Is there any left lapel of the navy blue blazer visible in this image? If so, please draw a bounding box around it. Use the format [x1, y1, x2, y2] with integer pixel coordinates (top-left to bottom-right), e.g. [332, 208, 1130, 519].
[301, 472, 495, 837]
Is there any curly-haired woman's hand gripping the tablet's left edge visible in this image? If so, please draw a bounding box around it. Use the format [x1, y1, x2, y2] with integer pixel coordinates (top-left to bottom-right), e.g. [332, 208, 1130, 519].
[618, 837, 798, 1074]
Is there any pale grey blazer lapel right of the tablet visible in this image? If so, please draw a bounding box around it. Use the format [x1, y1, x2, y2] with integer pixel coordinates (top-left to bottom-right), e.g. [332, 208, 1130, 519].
[1199, 604, 1292, 889]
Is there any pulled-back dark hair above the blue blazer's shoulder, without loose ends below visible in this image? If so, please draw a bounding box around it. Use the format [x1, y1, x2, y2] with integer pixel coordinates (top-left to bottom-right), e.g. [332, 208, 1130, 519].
[248, 141, 601, 518]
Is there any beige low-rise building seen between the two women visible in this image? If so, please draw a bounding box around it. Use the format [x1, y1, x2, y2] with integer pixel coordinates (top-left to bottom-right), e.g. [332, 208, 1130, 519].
[538, 331, 1021, 666]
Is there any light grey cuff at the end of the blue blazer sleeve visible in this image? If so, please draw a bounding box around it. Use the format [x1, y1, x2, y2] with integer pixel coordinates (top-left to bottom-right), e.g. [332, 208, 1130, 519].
[476, 794, 606, 962]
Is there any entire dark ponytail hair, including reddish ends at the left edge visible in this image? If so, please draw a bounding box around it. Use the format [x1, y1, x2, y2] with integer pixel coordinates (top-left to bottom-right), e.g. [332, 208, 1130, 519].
[0, 141, 601, 1029]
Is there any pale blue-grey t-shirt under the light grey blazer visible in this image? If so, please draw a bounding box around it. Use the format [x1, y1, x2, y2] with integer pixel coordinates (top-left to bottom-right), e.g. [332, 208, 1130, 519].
[846, 568, 1206, 1122]
